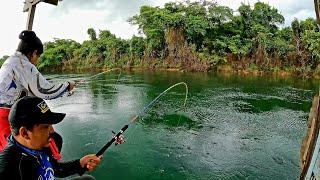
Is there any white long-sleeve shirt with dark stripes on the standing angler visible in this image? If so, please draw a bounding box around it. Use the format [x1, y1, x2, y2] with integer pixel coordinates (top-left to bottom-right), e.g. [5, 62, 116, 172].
[0, 52, 69, 106]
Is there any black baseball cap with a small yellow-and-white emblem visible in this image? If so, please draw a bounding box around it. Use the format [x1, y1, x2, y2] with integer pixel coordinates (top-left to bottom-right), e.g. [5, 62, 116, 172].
[9, 96, 66, 128]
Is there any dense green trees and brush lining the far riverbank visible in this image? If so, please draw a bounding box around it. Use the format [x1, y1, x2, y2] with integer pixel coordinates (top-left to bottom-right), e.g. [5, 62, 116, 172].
[0, 1, 320, 76]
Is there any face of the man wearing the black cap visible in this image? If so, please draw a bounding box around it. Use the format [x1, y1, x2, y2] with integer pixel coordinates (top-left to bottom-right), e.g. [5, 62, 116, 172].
[28, 124, 54, 150]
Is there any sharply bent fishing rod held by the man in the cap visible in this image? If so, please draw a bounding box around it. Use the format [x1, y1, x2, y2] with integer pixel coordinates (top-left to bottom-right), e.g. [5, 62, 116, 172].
[79, 82, 188, 175]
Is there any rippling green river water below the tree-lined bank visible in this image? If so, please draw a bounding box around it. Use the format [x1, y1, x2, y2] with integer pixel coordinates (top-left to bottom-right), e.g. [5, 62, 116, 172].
[46, 72, 319, 180]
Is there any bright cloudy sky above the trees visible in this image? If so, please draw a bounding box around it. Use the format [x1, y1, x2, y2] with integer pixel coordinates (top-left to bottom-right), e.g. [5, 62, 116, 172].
[0, 0, 315, 57]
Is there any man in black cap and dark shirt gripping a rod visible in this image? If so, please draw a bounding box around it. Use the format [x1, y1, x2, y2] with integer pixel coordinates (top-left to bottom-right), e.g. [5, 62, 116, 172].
[0, 97, 101, 180]
